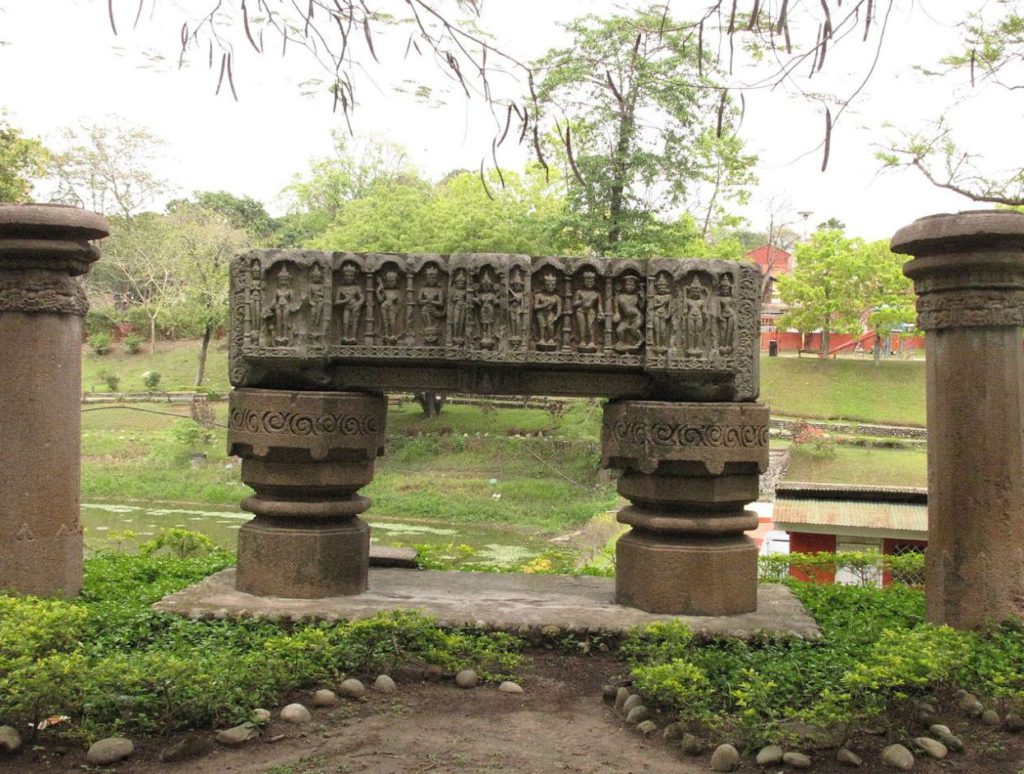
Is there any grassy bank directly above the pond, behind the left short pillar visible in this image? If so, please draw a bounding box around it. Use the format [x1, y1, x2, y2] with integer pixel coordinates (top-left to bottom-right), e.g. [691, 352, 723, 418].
[82, 402, 617, 532]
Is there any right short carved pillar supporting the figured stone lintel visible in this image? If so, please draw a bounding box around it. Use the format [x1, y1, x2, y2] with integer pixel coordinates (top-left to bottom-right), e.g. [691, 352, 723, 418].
[601, 400, 768, 615]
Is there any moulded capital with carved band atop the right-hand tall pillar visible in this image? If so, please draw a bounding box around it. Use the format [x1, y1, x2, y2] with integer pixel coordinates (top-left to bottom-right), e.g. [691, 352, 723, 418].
[892, 210, 1024, 331]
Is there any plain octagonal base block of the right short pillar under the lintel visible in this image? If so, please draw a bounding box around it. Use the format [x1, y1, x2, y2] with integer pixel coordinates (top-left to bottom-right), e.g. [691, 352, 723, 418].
[615, 529, 758, 615]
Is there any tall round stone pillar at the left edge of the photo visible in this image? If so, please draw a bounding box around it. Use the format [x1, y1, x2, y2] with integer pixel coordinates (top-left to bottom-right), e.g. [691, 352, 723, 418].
[0, 205, 109, 596]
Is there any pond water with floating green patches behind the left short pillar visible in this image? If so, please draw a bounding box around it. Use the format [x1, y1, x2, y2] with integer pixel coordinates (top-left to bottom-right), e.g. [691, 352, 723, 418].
[82, 503, 565, 569]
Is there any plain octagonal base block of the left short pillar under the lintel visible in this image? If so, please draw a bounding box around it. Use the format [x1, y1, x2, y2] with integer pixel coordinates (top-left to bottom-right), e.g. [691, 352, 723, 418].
[236, 517, 370, 599]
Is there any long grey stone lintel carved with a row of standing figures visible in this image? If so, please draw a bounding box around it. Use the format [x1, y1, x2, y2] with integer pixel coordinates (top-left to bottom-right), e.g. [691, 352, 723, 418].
[229, 250, 760, 402]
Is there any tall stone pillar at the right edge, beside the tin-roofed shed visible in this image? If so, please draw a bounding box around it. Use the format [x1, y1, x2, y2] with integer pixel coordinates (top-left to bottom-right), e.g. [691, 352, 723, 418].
[892, 211, 1024, 629]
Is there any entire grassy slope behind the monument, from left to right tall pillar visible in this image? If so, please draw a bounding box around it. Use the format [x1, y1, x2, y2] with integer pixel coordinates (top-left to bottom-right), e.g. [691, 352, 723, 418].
[82, 342, 925, 513]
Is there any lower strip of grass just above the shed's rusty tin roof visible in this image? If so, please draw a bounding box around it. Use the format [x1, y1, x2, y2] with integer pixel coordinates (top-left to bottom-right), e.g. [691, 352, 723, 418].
[785, 446, 928, 486]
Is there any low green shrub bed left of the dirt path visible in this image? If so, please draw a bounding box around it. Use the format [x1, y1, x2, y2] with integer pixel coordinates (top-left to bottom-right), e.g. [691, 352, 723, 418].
[0, 549, 521, 739]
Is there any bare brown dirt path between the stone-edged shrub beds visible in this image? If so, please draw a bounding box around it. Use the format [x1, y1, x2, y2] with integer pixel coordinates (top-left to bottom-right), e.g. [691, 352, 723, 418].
[6, 653, 1024, 774]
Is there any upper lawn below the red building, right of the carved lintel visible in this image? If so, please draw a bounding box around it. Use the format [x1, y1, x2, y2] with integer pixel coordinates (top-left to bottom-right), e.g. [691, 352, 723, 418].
[761, 357, 925, 427]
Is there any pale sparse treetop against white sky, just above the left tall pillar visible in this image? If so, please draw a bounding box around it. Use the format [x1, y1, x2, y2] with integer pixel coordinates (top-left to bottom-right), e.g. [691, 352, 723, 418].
[52, 124, 170, 218]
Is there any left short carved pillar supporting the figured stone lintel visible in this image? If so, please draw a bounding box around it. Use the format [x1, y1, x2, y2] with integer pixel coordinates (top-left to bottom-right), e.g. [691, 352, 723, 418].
[227, 388, 387, 599]
